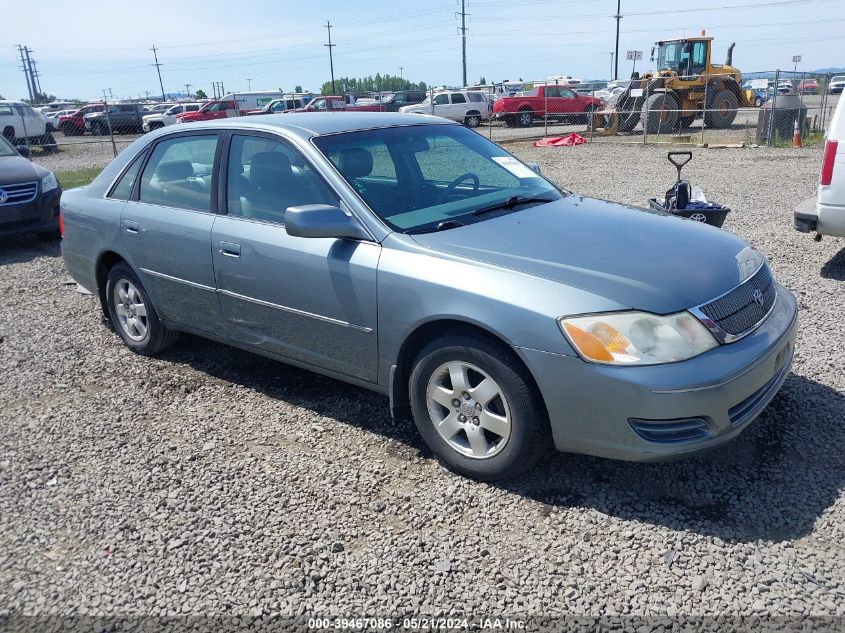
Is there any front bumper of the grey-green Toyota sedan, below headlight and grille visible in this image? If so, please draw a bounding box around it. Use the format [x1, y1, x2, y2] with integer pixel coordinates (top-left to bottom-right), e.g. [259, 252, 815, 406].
[516, 285, 797, 461]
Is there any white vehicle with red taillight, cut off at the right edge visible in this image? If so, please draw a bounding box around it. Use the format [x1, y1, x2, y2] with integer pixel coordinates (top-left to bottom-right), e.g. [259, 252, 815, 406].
[794, 97, 845, 241]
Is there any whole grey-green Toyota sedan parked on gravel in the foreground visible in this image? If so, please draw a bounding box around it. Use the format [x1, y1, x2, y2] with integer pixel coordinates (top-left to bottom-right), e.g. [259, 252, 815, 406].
[61, 112, 796, 480]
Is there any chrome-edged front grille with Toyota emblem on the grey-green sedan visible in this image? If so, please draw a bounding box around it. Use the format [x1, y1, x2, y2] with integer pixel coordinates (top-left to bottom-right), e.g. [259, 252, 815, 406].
[699, 264, 776, 336]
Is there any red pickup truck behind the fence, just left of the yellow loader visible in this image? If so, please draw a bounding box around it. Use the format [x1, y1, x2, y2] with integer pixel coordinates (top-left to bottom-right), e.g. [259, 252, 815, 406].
[493, 84, 605, 127]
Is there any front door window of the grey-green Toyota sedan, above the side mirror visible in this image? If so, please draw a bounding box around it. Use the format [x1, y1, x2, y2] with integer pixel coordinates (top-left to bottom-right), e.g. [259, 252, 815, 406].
[231, 135, 338, 224]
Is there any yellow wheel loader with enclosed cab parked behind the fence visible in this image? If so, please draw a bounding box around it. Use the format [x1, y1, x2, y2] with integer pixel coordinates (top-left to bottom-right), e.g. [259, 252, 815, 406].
[593, 31, 755, 134]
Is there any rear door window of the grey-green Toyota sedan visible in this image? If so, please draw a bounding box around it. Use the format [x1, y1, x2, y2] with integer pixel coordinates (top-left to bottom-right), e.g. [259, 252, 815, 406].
[140, 134, 218, 211]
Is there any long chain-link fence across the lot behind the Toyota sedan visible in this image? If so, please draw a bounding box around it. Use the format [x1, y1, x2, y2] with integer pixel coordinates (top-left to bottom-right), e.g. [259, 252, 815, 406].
[9, 70, 841, 169]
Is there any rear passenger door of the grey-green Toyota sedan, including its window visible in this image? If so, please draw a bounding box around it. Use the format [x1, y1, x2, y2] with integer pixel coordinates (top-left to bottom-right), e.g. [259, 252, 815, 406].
[120, 131, 223, 336]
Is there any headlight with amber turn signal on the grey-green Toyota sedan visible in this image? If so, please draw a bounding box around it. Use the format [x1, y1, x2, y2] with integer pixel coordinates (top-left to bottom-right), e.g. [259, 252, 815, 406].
[558, 312, 718, 365]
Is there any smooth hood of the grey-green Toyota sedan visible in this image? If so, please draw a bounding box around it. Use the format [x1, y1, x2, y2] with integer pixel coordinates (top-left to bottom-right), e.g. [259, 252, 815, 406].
[413, 194, 764, 314]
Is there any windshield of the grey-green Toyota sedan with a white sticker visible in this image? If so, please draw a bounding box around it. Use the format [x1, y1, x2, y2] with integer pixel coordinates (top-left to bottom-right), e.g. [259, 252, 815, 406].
[314, 125, 561, 233]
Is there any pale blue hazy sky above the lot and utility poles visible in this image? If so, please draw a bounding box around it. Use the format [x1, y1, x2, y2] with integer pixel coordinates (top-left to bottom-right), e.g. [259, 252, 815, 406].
[0, 0, 845, 99]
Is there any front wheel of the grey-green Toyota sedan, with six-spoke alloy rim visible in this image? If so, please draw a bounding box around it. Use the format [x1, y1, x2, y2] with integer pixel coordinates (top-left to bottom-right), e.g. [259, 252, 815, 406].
[409, 331, 551, 481]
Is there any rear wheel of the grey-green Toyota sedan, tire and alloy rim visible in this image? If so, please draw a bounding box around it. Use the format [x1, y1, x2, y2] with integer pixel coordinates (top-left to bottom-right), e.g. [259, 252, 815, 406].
[106, 262, 178, 356]
